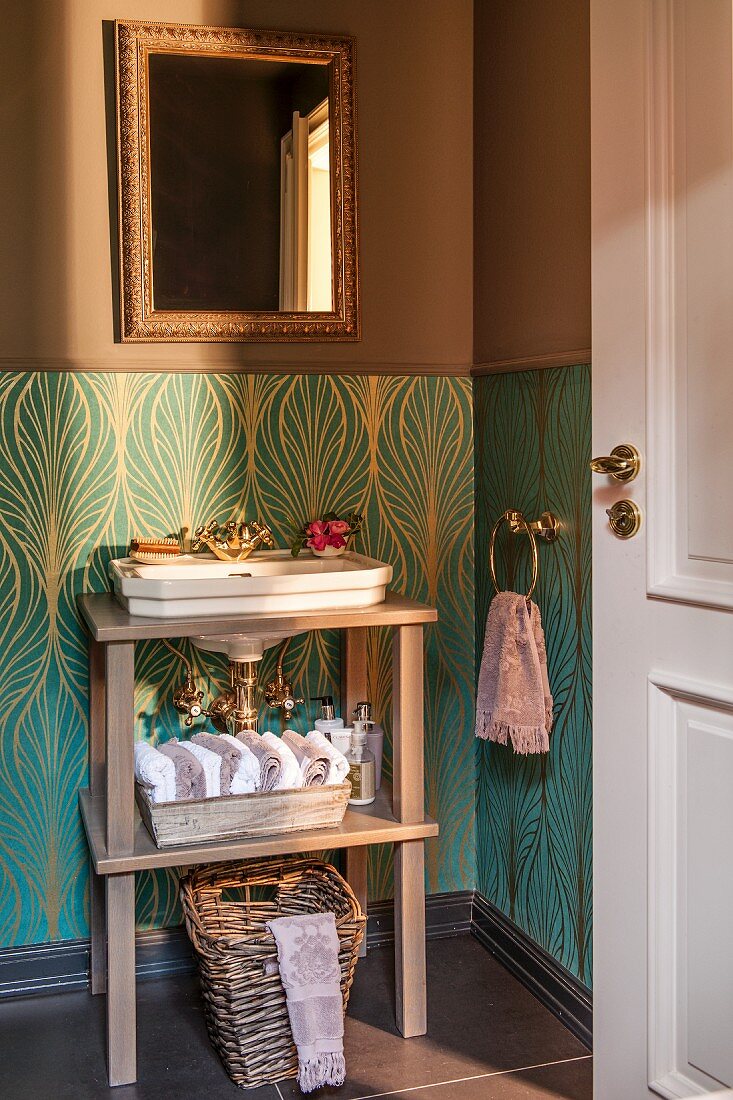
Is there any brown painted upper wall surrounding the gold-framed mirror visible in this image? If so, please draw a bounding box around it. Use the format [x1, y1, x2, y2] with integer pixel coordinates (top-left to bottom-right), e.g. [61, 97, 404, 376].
[0, 0, 472, 372]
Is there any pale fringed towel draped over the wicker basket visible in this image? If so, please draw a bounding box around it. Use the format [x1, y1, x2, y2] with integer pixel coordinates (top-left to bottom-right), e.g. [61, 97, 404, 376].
[267, 913, 346, 1092]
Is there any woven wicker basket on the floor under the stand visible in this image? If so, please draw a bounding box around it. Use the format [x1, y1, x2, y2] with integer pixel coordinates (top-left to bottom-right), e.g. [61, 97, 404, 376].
[180, 857, 367, 1088]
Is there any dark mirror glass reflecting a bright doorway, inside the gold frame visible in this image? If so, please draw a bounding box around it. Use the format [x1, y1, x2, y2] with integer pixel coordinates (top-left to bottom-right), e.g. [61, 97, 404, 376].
[149, 52, 333, 312]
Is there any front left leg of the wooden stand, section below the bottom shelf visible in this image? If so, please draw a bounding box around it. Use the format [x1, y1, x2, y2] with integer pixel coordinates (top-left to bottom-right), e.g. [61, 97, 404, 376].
[107, 872, 138, 1085]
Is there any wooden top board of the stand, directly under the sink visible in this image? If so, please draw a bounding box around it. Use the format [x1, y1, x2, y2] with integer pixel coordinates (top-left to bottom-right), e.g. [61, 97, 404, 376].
[77, 592, 438, 642]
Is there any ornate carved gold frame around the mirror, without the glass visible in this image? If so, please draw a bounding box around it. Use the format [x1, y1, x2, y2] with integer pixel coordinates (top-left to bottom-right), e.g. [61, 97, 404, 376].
[116, 21, 360, 343]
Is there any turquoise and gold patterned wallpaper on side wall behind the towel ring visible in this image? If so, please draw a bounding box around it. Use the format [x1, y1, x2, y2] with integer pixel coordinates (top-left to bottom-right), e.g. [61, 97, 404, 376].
[474, 366, 592, 985]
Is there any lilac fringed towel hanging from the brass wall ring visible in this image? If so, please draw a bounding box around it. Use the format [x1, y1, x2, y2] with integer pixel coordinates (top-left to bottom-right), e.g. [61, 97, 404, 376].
[475, 592, 553, 756]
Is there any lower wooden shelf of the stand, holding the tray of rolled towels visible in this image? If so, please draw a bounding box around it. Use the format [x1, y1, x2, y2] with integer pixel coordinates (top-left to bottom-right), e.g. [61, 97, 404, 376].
[79, 783, 438, 875]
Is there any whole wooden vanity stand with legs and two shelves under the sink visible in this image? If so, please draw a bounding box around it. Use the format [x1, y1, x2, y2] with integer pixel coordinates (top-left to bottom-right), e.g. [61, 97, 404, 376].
[78, 593, 438, 1085]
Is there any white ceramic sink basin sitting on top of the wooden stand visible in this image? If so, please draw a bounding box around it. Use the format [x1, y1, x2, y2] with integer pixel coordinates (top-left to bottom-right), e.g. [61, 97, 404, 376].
[109, 550, 392, 618]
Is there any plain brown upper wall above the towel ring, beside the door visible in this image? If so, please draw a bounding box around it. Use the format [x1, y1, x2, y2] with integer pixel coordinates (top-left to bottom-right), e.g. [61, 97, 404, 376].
[474, 0, 590, 365]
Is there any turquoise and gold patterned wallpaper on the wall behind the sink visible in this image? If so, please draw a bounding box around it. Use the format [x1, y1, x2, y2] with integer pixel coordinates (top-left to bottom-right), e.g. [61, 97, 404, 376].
[0, 373, 474, 947]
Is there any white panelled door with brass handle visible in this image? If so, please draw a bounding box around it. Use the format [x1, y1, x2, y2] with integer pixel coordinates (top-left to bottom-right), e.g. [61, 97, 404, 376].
[591, 0, 733, 1100]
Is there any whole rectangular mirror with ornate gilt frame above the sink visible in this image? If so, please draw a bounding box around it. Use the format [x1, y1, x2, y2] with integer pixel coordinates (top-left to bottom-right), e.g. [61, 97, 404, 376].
[114, 20, 360, 342]
